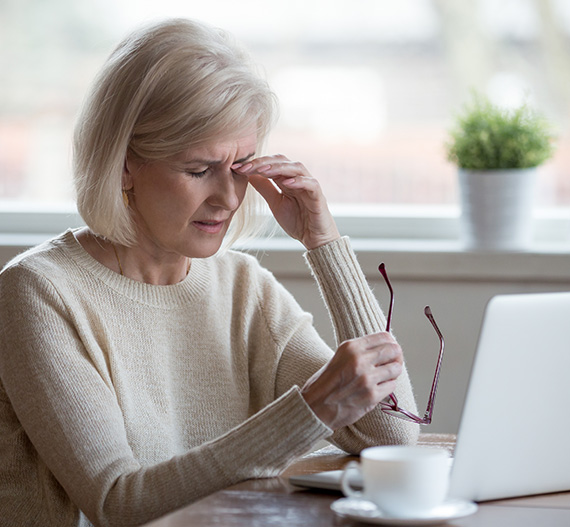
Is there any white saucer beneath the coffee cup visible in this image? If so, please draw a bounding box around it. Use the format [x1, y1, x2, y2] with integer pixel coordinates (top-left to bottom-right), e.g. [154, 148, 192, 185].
[331, 498, 477, 525]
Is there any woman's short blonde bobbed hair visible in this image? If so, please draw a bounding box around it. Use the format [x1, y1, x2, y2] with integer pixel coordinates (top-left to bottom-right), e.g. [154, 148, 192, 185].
[73, 19, 276, 245]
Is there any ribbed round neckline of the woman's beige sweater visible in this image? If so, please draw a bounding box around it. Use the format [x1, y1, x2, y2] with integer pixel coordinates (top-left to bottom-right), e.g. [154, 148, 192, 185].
[60, 229, 212, 307]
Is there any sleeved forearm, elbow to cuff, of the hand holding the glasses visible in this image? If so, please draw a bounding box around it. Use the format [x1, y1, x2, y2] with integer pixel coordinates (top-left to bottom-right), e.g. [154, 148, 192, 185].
[93, 389, 331, 526]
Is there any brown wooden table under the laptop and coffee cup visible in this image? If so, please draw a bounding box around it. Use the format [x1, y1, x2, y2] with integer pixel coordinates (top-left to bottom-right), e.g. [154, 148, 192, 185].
[142, 434, 570, 527]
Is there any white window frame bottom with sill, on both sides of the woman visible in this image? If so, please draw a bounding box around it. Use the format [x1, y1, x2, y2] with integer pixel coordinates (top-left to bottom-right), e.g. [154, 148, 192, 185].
[0, 206, 570, 283]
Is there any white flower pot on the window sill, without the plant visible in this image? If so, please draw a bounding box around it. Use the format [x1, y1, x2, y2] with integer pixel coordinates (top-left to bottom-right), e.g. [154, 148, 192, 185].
[459, 168, 536, 251]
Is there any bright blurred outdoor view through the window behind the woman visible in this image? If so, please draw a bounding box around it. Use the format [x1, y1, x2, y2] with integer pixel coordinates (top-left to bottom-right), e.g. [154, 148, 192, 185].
[0, 0, 570, 212]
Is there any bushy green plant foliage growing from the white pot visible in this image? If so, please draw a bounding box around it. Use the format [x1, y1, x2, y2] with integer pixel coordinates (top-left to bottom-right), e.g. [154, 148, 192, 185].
[446, 93, 554, 170]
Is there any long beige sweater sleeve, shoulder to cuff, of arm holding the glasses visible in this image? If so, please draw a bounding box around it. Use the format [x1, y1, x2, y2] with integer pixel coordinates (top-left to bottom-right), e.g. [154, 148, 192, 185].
[0, 266, 331, 526]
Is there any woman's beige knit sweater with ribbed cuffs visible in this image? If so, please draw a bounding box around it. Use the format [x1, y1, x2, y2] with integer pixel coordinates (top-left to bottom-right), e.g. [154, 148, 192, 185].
[0, 231, 418, 527]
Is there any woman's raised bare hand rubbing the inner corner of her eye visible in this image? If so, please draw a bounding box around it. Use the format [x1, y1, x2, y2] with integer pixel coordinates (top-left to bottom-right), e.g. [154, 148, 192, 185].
[232, 155, 340, 250]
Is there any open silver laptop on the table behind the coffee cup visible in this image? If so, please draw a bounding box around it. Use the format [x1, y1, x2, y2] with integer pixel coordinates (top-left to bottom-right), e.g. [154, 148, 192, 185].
[290, 293, 570, 501]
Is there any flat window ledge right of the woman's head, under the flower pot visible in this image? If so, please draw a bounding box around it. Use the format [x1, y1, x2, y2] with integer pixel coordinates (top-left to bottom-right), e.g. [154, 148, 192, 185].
[241, 238, 570, 282]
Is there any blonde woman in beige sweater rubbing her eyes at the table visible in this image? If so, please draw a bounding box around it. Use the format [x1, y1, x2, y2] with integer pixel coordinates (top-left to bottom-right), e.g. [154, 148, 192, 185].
[0, 20, 418, 527]
